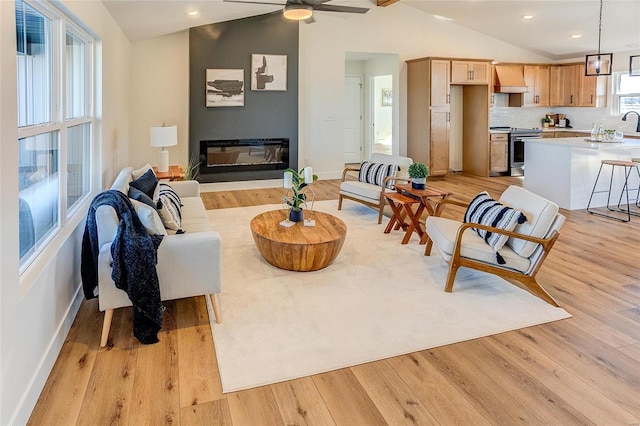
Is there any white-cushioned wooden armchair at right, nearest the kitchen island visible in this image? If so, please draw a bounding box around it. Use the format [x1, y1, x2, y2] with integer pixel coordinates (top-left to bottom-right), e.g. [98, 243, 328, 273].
[425, 186, 565, 306]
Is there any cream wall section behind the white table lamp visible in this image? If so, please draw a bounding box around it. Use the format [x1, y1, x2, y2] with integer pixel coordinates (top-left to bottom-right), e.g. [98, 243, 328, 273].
[128, 31, 190, 167]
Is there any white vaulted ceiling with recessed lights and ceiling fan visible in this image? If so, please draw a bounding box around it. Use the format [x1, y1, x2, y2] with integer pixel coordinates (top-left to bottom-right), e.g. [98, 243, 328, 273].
[103, 0, 640, 60]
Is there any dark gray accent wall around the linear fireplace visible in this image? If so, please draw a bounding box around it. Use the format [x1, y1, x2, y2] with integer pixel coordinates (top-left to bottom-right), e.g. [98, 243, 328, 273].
[189, 12, 299, 182]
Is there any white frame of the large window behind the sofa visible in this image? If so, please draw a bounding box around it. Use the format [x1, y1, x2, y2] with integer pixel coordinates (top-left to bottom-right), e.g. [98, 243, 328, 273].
[15, 0, 99, 272]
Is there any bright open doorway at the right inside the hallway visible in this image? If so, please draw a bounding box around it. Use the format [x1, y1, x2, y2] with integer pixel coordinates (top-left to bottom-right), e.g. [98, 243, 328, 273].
[371, 75, 393, 155]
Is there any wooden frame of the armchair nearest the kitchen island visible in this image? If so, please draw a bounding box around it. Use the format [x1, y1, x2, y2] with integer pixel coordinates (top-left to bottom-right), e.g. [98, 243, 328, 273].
[424, 199, 560, 306]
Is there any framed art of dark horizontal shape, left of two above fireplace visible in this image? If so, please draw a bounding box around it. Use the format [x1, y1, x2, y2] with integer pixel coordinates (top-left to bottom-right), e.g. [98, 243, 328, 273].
[206, 69, 244, 107]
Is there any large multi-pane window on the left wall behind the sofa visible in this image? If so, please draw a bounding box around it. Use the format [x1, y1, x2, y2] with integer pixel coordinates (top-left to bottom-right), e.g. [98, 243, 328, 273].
[15, 0, 93, 272]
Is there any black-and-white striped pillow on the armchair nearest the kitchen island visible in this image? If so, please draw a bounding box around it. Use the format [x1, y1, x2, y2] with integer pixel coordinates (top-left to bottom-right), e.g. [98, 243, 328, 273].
[464, 191, 527, 264]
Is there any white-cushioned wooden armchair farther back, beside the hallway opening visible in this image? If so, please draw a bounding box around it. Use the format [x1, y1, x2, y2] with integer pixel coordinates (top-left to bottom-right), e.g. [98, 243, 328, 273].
[338, 154, 413, 223]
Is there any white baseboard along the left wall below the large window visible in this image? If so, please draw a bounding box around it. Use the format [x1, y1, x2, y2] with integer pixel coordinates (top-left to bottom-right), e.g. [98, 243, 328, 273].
[9, 284, 84, 425]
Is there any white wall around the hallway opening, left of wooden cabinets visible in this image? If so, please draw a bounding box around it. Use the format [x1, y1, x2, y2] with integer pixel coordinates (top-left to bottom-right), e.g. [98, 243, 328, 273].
[299, 2, 549, 178]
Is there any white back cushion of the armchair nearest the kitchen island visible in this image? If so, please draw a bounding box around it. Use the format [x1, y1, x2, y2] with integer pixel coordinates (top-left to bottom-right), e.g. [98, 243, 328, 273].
[498, 186, 558, 257]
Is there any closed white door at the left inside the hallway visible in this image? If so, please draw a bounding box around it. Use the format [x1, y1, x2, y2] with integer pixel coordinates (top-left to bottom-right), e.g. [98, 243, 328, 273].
[344, 75, 364, 163]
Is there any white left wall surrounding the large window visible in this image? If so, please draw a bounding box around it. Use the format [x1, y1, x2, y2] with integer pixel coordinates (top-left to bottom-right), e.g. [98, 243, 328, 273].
[0, 1, 130, 425]
